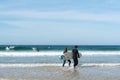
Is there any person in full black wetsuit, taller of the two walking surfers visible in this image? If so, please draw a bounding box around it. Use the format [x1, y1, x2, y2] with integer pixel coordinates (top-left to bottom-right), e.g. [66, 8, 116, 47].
[72, 45, 80, 69]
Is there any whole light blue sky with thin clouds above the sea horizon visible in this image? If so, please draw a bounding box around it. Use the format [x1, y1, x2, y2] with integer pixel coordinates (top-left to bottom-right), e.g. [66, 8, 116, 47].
[0, 0, 120, 45]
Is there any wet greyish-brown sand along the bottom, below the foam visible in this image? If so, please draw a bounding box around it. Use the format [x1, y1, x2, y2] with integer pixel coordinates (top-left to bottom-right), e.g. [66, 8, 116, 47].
[0, 66, 120, 80]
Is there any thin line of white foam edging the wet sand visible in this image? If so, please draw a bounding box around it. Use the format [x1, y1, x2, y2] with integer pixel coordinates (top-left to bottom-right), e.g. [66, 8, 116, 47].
[0, 63, 120, 68]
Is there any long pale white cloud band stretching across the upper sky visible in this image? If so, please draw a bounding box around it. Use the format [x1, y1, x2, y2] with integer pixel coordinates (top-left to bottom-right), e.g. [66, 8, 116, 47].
[0, 10, 120, 23]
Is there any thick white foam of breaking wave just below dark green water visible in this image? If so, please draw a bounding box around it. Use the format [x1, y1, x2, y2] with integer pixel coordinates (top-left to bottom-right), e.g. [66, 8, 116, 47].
[0, 51, 120, 57]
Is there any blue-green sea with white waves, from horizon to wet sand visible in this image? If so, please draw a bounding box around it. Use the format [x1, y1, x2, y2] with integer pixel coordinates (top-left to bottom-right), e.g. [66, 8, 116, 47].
[0, 45, 120, 67]
